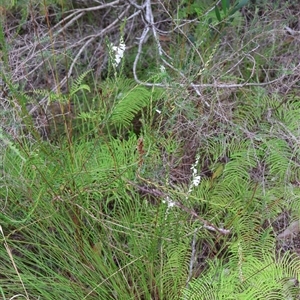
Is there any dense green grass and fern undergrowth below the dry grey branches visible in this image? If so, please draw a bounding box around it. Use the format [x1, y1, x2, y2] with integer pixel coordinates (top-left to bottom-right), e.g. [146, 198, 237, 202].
[0, 84, 300, 299]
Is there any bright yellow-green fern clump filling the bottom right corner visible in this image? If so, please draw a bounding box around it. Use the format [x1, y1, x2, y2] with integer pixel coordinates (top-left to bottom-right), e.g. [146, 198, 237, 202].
[182, 250, 300, 300]
